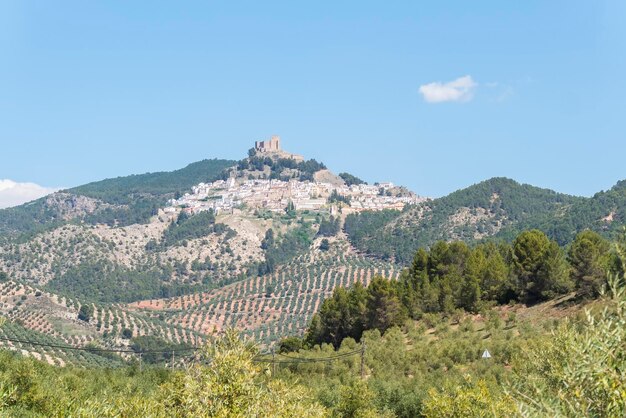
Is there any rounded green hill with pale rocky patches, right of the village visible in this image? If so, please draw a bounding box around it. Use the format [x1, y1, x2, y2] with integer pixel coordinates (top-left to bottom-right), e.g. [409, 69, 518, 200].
[345, 178, 585, 264]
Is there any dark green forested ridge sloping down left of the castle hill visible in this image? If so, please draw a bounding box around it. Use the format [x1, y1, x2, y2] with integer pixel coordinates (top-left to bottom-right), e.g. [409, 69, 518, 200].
[0, 159, 236, 237]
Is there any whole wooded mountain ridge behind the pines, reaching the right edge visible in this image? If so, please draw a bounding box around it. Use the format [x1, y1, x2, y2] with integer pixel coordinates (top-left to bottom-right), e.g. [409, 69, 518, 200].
[345, 178, 626, 265]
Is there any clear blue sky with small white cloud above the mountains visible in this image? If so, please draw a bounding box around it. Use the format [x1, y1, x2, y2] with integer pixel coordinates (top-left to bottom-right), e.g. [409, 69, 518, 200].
[0, 0, 626, 204]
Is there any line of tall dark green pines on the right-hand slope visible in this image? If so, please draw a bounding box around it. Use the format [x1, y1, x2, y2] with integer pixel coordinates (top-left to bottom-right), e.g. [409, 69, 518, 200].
[305, 230, 624, 347]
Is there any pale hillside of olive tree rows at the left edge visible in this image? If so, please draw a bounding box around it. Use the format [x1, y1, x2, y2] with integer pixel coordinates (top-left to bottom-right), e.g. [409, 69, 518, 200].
[0, 281, 204, 365]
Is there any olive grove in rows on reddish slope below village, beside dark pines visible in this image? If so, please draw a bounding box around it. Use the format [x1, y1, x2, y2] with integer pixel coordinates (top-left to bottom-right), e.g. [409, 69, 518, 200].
[134, 242, 400, 345]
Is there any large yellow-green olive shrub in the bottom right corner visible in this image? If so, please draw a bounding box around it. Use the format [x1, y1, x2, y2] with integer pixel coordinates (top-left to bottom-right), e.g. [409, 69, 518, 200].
[509, 279, 626, 417]
